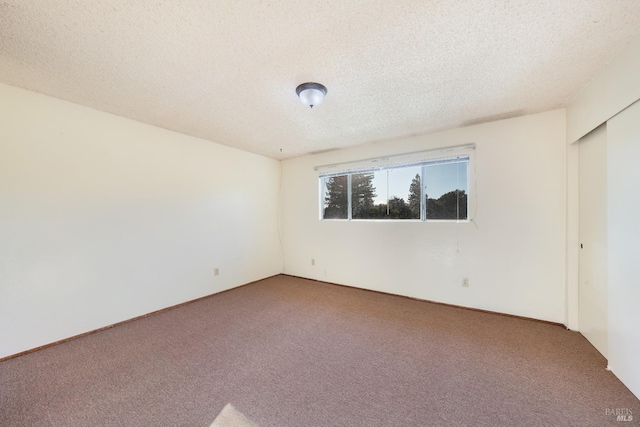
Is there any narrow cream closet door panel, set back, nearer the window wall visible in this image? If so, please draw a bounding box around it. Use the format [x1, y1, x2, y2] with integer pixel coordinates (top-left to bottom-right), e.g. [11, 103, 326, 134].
[578, 124, 608, 357]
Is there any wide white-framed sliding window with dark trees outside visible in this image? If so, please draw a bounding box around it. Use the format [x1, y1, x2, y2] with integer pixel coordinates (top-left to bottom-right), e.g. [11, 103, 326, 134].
[320, 149, 470, 221]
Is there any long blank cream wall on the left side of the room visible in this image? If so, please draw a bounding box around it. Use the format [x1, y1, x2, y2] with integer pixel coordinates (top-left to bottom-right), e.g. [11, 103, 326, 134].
[0, 84, 282, 357]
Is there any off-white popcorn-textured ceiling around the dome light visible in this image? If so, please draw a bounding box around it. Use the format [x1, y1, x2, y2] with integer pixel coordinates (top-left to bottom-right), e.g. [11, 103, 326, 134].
[0, 0, 640, 159]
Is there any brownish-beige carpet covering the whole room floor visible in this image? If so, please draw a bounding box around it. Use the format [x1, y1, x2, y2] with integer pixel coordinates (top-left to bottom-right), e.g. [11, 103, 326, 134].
[0, 276, 640, 427]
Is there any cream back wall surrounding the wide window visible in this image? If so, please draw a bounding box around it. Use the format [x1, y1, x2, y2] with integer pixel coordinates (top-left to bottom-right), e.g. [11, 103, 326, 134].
[281, 110, 567, 322]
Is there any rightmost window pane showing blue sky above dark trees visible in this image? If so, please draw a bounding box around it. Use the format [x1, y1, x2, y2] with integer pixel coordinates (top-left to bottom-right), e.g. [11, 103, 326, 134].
[425, 161, 469, 220]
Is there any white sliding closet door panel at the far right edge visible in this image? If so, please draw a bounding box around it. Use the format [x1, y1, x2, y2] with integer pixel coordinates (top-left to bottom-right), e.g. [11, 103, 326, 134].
[607, 101, 640, 397]
